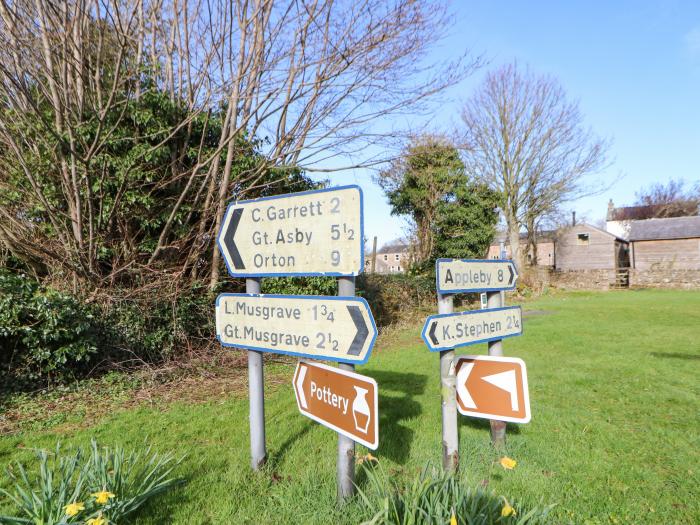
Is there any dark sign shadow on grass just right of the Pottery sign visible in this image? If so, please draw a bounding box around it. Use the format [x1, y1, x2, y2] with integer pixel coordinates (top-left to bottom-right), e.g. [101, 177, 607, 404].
[368, 370, 428, 465]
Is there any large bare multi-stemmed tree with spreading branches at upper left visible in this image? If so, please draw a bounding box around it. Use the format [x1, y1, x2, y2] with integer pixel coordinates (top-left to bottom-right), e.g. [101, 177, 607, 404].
[0, 0, 478, 286]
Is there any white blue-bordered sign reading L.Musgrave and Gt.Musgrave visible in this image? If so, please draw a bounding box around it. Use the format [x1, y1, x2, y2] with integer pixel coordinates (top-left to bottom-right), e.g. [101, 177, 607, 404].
[216, 293, 377, 364]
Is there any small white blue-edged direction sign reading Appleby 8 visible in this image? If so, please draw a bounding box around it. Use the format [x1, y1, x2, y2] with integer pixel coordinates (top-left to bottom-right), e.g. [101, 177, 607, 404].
[435, 259, 518, 294]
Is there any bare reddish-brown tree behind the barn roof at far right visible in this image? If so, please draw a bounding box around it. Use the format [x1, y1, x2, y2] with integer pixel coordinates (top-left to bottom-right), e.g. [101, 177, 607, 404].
[634, 179, 700, 218]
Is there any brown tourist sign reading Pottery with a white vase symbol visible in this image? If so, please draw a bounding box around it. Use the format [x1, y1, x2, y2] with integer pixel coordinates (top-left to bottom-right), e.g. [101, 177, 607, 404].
[292, 361, 379, 450]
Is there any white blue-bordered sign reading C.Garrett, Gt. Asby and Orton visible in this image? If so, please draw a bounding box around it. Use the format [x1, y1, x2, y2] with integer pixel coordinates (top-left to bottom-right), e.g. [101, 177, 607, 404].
[217, 186, 364, 277]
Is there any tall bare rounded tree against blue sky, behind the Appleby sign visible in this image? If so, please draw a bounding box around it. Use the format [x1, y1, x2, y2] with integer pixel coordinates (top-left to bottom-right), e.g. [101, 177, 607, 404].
[462, 63, 608, 268]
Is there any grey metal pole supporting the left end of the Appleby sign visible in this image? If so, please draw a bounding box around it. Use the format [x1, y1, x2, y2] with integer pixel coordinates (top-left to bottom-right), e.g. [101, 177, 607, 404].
[438, 293, 459, 471]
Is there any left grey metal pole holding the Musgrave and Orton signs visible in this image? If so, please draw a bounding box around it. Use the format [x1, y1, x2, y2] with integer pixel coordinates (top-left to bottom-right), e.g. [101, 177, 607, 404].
[245, 278, 267, 470]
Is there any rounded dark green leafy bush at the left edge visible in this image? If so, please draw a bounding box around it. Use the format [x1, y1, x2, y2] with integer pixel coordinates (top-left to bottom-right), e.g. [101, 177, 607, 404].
[0, 268, 98, 387]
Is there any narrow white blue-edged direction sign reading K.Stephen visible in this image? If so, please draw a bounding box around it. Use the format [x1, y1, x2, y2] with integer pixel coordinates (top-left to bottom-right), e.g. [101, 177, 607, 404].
[421, 306, 523, 352]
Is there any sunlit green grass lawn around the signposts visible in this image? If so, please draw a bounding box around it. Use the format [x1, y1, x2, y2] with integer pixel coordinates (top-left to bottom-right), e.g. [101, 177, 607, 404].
[0, 290, 700, 525]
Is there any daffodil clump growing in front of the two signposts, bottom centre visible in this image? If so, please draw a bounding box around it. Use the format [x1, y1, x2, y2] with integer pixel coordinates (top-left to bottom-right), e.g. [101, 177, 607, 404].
[358, 462, 552, 525]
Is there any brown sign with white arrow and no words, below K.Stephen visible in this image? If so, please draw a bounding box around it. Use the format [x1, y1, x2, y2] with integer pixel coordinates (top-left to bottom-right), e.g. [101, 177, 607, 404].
[455, 355, 530, 423]
